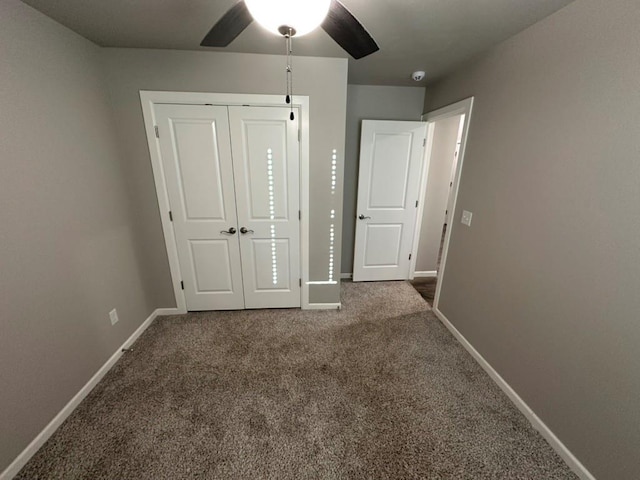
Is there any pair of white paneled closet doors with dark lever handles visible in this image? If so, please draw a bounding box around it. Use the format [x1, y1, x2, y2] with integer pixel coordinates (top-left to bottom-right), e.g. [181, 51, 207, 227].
[155, 105, 300, 311]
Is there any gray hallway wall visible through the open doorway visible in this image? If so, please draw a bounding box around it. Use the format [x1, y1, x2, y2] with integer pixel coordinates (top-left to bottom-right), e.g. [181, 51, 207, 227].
[416, 115, 461, 272]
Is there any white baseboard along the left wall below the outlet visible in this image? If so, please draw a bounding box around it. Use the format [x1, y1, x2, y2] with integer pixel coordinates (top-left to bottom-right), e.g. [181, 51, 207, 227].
[0, 308, 170, 480]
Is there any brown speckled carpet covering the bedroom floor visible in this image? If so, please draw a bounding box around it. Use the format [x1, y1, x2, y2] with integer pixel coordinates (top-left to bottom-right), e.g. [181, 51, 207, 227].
[17, 282, 577, 480]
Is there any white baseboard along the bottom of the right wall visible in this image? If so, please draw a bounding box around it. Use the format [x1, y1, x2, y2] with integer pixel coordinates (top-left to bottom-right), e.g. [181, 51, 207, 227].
[433, 307, 596, 480]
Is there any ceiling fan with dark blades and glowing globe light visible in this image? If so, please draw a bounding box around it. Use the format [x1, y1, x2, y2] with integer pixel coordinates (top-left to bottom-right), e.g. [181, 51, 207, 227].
[200, 0, 379, 59]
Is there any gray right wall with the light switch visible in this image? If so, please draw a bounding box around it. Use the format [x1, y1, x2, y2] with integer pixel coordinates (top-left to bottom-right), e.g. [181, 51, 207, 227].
[425, 0, 640, 480]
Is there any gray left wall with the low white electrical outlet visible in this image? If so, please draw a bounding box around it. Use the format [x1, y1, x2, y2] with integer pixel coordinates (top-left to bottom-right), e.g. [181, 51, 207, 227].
[0, 0, 157, 471]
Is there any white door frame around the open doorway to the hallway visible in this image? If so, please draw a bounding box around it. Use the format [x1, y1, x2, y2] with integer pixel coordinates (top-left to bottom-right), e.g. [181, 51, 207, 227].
[409, 97, 474, 309]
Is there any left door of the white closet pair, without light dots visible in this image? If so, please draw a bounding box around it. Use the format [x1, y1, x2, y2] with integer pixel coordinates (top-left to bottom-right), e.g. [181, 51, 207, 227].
[155, 105, 244, 310]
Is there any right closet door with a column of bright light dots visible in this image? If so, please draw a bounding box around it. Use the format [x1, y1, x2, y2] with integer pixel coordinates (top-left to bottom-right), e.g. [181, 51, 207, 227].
[229, 106, 301, 308]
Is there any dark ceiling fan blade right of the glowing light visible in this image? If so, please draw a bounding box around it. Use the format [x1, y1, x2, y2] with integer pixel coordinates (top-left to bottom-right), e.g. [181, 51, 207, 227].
[322, 0, 380, 60]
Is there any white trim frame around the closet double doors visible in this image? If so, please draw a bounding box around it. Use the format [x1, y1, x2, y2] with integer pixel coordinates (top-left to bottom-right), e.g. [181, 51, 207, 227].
[140, 90, 309, 313]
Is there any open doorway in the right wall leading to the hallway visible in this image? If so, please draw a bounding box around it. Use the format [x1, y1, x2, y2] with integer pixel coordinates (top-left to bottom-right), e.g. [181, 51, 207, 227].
[411, 99, 472, 307]
